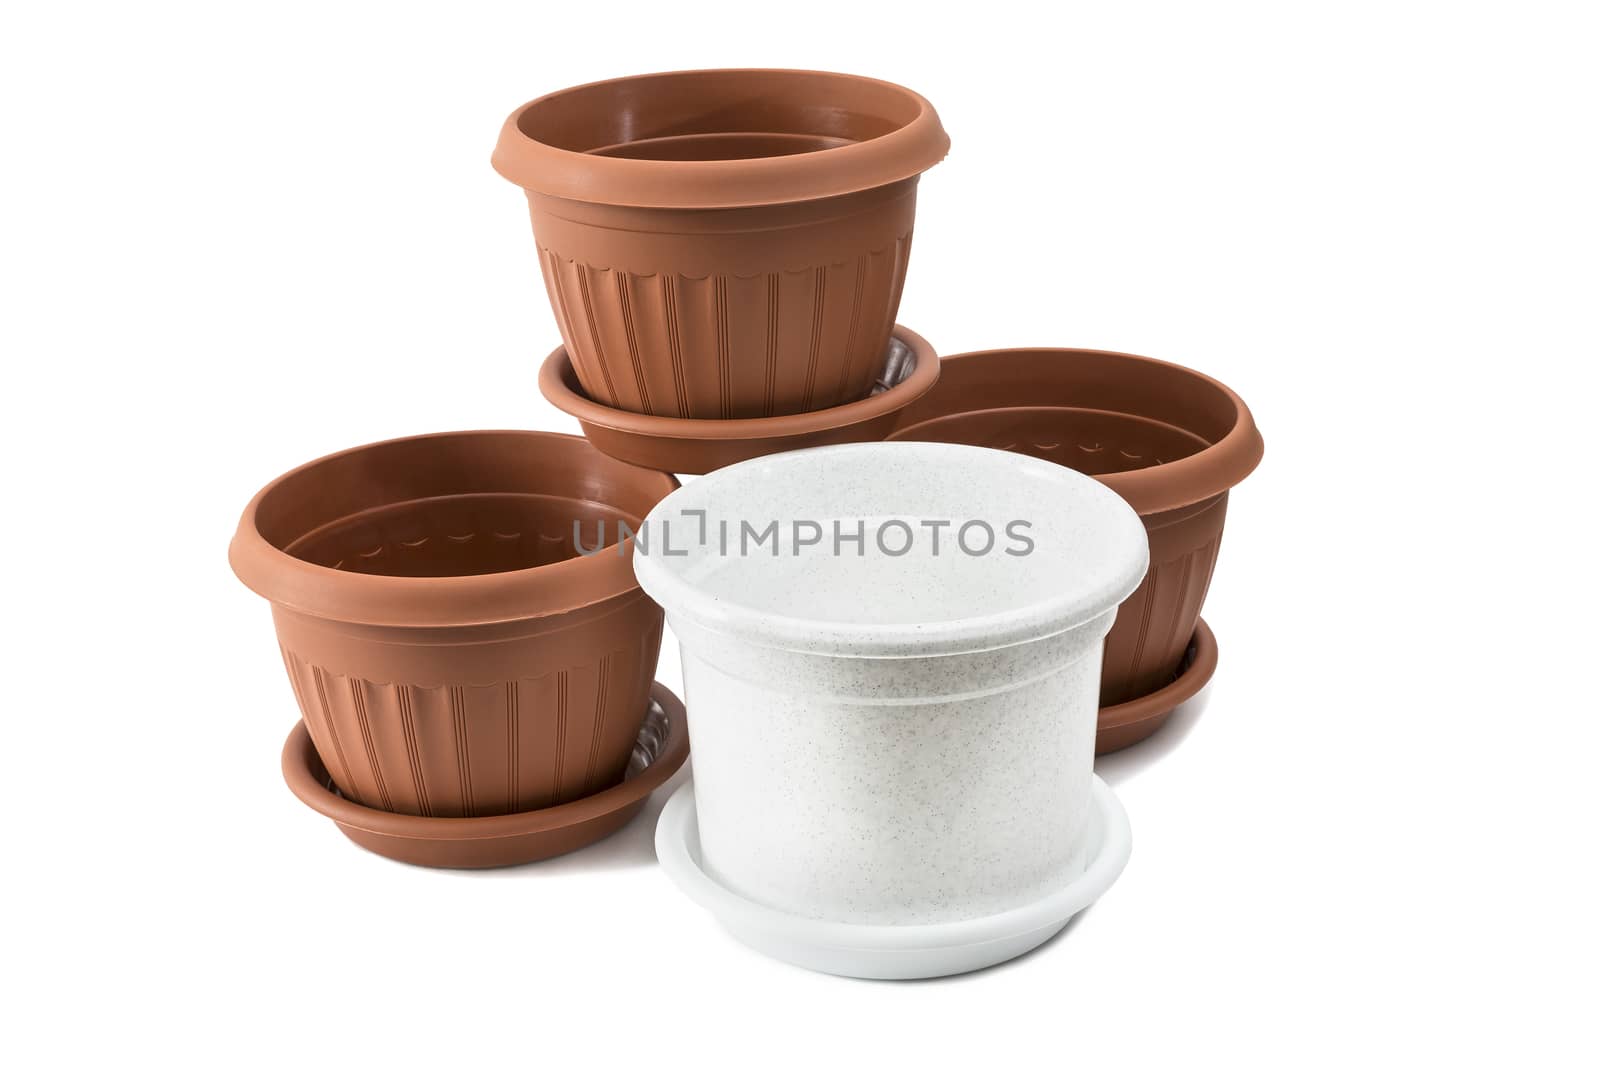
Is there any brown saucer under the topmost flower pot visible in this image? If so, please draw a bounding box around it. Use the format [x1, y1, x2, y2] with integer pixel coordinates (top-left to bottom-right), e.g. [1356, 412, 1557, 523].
[539, 326, 939, 474]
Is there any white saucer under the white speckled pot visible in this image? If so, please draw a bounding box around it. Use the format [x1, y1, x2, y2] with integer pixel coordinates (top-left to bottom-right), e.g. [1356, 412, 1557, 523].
[656, 776, 1133, 977]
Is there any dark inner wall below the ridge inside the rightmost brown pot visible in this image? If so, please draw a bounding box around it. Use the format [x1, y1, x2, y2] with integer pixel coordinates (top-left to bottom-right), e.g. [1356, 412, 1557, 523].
[894, 406, 1210, 475]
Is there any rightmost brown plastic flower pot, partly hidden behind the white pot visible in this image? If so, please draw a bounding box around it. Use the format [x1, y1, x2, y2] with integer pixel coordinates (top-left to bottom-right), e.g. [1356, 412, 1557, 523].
[890, 349, 1262, 752]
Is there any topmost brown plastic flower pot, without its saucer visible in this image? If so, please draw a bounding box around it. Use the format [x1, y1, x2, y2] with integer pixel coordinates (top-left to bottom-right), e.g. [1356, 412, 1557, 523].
[493, 70, 950, 419]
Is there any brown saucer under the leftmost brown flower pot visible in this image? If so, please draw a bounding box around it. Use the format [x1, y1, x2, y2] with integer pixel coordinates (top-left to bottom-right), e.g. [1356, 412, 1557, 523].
[283, 681, 690, 867]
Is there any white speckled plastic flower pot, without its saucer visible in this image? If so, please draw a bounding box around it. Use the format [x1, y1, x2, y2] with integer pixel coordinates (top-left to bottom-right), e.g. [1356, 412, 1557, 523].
[635, 442, 1147, 979]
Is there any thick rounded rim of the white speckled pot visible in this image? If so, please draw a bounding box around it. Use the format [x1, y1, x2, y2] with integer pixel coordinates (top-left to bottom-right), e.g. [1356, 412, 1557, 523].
[634, 442, 1149, 657]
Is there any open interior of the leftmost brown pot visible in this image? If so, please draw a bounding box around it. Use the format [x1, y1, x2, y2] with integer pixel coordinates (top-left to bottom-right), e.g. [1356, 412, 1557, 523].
[256, 432, 675, 577]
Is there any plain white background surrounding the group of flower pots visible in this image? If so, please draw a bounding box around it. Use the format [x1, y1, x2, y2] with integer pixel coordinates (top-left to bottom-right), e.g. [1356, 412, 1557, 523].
[0, 0, 1600, 1064]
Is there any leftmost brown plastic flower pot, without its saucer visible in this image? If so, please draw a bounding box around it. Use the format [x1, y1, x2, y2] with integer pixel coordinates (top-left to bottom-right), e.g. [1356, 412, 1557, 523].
[229, 430, 677, 816]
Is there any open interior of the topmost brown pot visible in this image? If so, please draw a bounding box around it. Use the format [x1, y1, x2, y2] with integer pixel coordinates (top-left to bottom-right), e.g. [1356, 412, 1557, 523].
[517, 70, 922, 160]
